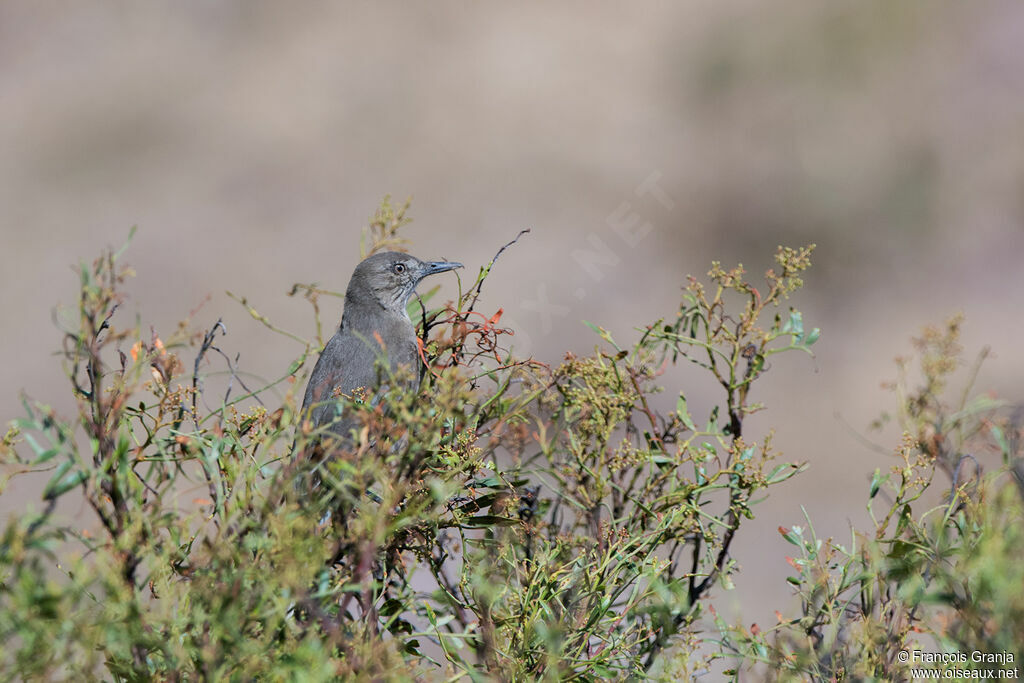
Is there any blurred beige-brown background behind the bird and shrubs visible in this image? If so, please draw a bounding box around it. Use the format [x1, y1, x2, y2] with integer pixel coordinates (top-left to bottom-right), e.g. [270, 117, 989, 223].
[0, 0, 1024, 634]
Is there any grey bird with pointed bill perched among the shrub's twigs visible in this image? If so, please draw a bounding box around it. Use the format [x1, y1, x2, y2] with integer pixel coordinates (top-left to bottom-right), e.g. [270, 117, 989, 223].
[301, 252, 462, 446]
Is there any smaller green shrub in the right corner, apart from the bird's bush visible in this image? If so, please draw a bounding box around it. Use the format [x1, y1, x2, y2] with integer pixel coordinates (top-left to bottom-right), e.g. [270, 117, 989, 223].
[720, 315, 1024, 681]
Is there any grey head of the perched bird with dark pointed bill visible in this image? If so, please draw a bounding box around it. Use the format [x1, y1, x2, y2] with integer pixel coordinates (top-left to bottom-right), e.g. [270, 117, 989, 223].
[345, 252, 462, 313]
